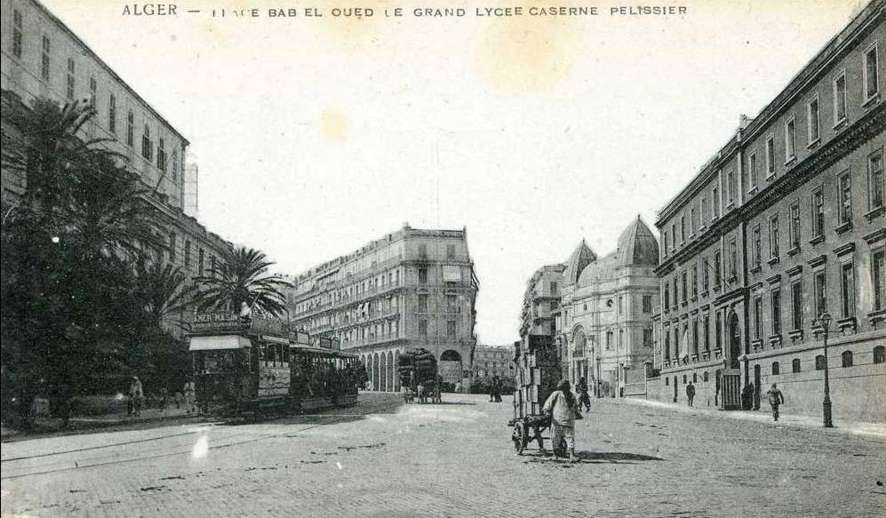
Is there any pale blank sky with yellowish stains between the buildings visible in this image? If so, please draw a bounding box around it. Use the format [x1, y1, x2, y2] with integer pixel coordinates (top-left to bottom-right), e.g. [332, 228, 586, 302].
[42, 0, 863, 345]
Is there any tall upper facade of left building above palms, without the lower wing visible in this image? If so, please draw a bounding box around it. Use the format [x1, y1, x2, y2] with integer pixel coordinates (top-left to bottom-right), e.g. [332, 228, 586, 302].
[0, 0, 189, 210]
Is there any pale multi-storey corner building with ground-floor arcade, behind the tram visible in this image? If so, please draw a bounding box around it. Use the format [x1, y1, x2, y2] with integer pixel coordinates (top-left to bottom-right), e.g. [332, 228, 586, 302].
[287, 225, 479, 391]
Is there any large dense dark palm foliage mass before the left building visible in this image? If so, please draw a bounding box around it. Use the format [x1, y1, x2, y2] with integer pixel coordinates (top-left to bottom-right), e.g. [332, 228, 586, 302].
[2, 98, 162, 427]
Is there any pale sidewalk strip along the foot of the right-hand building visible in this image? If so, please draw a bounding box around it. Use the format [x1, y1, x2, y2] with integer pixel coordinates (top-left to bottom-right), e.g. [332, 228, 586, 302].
[622, 398, 886, 438]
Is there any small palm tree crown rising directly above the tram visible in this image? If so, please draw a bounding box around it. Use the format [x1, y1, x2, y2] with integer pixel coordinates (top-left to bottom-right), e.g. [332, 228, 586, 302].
[195, 246, 291, 317]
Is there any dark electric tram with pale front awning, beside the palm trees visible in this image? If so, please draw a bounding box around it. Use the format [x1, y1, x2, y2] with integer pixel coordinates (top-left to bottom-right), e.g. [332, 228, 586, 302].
[188, 313, 363, 416]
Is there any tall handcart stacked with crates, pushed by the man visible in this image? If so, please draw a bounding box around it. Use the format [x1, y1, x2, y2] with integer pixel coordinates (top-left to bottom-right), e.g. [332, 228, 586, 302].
[508, 335, 562, 454]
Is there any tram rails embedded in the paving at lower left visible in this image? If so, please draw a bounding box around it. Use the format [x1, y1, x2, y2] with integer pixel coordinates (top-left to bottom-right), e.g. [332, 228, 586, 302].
[0, 405, 392, 480]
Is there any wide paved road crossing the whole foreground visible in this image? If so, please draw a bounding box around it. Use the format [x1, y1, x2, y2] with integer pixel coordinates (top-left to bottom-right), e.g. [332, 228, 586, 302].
[0, 394, 886, 517]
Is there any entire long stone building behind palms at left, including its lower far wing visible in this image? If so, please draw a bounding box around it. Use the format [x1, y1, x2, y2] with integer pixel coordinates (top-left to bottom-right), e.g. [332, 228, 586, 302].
[0, 0, 230, 333]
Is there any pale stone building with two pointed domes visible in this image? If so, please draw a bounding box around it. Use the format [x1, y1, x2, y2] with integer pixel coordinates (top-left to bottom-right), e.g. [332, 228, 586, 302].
[556, 217, 658, 397]
